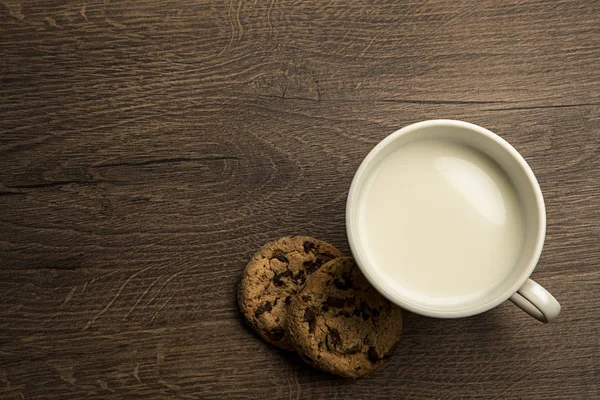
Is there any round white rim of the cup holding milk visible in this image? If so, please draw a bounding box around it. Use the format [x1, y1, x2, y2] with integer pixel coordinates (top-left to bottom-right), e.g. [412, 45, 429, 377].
[346, 119, 546, 318]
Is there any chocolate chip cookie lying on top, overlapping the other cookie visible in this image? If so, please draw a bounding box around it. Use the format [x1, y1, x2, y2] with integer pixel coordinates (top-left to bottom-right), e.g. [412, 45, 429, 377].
[288, 257, 402, 378]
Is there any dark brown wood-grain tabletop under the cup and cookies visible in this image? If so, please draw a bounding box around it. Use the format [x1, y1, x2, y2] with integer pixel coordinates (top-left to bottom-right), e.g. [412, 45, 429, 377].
[0, 0, 600, 400]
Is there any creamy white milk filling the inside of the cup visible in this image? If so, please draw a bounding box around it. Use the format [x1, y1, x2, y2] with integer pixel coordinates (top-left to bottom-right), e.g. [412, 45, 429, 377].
[358, 140, 524, 305]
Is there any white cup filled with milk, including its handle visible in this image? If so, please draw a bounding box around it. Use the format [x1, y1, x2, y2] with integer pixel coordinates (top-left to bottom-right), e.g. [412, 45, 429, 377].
[346, 120, 560, 322]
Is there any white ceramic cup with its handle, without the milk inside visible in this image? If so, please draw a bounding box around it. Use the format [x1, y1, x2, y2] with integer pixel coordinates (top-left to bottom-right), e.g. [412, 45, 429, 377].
[346, 120, 560, 322]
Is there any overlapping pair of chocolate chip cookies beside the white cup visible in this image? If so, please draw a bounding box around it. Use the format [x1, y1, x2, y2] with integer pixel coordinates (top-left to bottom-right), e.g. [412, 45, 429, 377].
[238, 236, 402, 378]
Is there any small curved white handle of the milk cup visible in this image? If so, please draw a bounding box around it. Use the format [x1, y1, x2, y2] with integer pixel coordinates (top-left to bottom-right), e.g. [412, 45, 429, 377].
[510, 279, 560, 322]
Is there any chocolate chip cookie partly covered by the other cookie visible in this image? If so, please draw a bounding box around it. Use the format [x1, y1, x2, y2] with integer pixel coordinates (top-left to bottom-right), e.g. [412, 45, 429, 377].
[238, 236, 342, 350]
